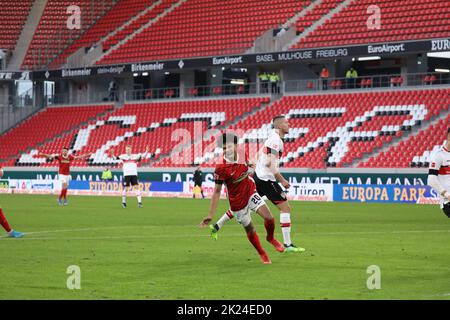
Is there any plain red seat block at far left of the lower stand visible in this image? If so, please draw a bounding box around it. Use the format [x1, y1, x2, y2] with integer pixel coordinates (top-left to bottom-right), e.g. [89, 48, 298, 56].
[0, 105, 112, 165]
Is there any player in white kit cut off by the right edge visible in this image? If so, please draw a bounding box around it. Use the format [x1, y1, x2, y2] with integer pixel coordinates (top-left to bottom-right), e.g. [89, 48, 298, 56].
[428, 128, 450, 218]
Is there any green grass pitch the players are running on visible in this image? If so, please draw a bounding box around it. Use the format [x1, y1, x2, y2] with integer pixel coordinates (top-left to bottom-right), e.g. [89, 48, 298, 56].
[0, 195, 450, 299]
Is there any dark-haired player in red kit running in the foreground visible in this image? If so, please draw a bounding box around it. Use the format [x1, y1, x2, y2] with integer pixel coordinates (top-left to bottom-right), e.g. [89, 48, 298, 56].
[200, 133, 284, 264]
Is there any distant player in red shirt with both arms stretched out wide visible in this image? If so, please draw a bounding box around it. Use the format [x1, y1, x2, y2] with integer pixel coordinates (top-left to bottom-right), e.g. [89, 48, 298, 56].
[38, 148, 90, 206]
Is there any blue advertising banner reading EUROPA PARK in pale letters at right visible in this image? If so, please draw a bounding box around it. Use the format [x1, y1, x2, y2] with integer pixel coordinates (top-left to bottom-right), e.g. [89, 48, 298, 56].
[333, 184, 439, 203]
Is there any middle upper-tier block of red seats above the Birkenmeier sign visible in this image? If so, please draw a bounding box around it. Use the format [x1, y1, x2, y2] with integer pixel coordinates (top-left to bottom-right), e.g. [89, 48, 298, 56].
[98, 0, 310, 64]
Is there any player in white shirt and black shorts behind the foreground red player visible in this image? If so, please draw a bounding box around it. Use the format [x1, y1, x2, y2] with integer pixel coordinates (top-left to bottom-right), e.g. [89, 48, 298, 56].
[211, 115, 305, 253]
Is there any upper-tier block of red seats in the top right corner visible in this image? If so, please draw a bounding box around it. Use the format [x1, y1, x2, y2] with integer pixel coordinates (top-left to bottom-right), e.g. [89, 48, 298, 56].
[292, 0, 450, 49]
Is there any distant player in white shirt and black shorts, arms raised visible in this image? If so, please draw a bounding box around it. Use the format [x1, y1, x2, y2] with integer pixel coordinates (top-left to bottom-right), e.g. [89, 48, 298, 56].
[111, 145, 149, 208]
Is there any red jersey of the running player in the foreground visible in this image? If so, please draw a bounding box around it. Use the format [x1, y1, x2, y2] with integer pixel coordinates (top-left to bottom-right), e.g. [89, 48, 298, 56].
[214, 156, 256, 211]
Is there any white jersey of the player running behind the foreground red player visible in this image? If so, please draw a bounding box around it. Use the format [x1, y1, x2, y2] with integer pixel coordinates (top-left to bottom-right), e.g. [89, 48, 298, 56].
[255, 130, 284, 181]
